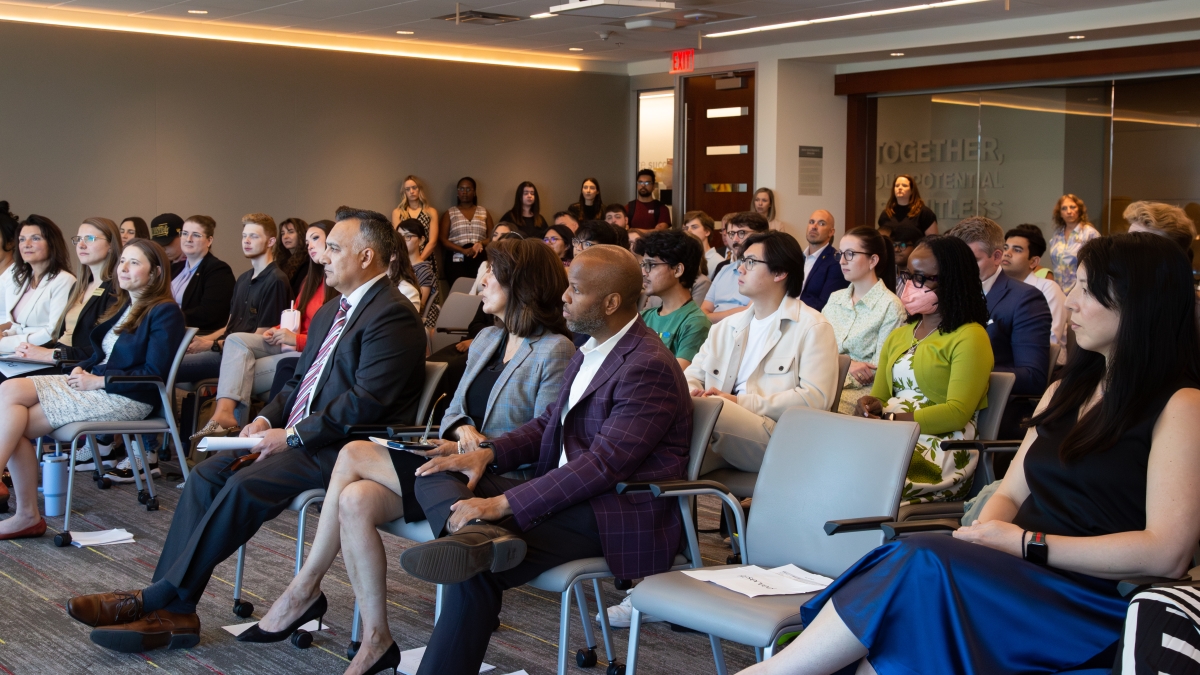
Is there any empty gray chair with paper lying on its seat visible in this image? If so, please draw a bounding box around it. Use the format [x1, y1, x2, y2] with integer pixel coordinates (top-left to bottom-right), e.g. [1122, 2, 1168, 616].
[625, 408, 919, 675]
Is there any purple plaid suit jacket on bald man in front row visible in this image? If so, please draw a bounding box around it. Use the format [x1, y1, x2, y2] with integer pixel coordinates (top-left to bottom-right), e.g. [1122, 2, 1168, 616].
[492, 317, 691, 579]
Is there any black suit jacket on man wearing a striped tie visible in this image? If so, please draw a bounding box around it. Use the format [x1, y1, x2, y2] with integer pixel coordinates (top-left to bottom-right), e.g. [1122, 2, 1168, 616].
[259, 277, 426, 453]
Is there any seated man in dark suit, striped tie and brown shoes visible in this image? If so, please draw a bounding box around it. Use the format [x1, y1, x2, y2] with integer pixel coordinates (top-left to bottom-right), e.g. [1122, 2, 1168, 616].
[67, 208, 426, 652]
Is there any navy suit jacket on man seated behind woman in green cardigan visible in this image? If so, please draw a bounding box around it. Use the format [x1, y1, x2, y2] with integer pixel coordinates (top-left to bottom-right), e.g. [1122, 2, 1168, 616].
[988, 271, 1052, 396]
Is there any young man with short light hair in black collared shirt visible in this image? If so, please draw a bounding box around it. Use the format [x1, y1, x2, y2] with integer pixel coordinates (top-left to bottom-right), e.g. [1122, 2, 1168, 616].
[172, 214, 292, 382]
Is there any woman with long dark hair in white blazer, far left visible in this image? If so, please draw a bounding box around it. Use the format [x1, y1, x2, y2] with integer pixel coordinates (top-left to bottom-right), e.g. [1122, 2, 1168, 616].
[0, 215, 76, 353]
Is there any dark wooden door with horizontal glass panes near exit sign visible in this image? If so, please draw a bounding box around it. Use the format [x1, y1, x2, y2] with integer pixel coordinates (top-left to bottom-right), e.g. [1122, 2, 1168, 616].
[680, 71, 755, 222]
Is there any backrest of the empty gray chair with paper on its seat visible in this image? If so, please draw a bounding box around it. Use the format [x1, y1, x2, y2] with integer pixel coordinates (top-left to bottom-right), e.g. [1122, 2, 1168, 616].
[745, 407, 920, 577]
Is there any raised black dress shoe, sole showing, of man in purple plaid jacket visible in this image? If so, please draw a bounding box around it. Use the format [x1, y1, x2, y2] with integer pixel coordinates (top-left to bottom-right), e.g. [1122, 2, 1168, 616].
[400, 521, 526, 584]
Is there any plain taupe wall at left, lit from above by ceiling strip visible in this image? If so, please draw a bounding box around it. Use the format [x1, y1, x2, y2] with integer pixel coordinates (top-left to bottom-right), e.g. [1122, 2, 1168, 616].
[0, 23, 632, 270]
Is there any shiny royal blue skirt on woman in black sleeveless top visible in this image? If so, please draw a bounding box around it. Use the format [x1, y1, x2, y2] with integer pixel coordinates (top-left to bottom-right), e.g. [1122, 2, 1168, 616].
[800, 534, 1128, 675]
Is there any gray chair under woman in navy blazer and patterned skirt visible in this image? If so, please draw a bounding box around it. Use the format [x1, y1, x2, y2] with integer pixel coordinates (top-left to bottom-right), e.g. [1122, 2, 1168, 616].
[50, 328, 198, 546]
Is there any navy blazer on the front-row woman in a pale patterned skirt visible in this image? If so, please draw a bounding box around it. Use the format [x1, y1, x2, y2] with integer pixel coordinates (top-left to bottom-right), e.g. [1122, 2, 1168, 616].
[79, 303, 186, 407]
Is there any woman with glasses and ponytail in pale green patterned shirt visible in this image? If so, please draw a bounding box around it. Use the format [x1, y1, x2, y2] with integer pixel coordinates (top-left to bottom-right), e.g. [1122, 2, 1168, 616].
[821, 227, 908, 414]
